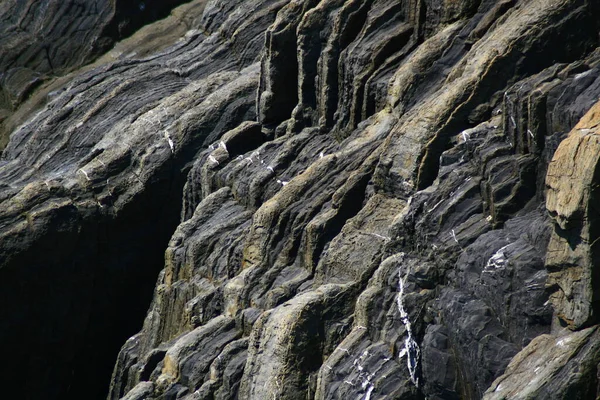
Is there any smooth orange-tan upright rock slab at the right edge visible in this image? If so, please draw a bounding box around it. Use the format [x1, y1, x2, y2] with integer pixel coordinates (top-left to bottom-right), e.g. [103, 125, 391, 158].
[546, 103, 600, 329]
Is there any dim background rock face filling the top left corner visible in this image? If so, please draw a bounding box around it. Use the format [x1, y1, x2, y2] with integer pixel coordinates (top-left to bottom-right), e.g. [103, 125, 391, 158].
[0, 0, 191, 147]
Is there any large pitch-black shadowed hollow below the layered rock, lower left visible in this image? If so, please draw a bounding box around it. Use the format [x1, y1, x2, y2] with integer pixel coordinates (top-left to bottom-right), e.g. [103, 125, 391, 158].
[0, 163, 186, 400]
